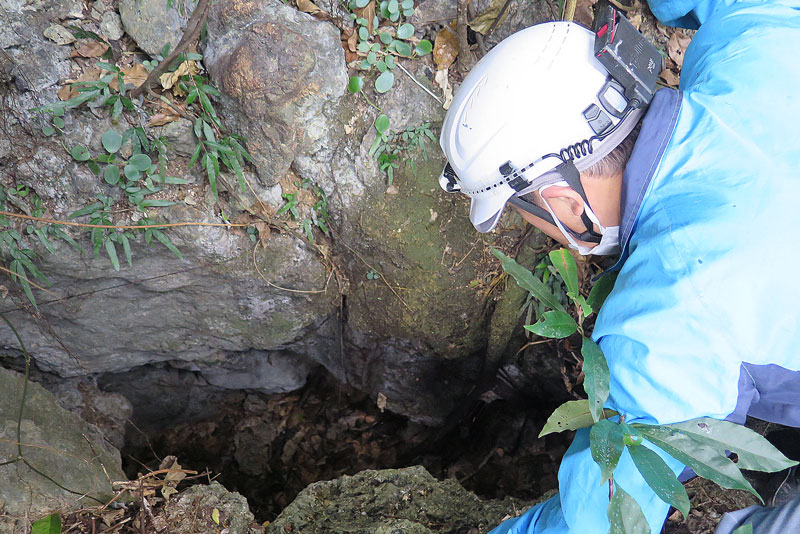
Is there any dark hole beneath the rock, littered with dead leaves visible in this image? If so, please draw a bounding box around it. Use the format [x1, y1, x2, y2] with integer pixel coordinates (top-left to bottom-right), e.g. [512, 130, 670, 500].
[114, 371, 572, 521]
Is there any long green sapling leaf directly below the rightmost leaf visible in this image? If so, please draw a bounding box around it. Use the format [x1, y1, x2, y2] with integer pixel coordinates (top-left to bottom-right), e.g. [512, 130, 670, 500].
[632, 424, 764, 503]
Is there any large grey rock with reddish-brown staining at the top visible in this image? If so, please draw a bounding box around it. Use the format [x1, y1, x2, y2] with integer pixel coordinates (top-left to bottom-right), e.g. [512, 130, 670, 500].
[205, 0, 347, 186]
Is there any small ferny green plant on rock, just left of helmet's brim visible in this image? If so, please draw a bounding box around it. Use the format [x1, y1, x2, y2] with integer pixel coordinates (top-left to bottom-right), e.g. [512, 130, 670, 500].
[369, 114, 436, 185]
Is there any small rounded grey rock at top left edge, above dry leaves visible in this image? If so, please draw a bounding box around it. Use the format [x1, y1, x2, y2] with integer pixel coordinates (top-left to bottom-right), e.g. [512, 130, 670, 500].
[119, 0, 196, 56]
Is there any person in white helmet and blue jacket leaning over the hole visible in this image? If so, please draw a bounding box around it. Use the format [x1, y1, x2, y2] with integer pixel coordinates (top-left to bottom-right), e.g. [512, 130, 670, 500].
[439, 0, 800, 534]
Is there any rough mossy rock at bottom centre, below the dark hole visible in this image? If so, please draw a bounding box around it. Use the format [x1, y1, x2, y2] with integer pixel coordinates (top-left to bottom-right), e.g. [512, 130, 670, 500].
[266, 466, 524, 534]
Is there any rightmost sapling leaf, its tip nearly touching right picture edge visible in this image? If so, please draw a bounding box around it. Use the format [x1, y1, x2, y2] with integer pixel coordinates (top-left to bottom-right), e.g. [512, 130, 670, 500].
[666, 417, 797, 473]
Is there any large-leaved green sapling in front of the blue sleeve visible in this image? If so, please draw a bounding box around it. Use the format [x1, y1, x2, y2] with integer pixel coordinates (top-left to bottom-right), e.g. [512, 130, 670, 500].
[494, 249, 798, 534]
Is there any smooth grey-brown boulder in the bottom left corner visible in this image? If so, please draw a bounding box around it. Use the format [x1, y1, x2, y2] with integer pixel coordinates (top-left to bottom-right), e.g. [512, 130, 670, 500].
[0, 368, 126, 534]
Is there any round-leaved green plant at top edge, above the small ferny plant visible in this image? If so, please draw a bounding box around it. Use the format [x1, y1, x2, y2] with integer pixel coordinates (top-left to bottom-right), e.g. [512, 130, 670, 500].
[348, 0, 433, 93]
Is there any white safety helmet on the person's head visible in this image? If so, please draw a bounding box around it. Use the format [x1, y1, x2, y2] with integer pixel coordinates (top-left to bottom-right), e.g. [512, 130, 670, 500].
[439, 22, 643, 232]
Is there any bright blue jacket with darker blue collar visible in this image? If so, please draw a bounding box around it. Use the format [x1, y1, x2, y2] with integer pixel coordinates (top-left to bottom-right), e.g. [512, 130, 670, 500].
[492, 0, 800, 534]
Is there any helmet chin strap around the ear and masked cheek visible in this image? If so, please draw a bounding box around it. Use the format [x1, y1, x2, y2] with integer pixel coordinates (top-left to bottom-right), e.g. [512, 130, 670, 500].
[509, 160, 603, 243]
